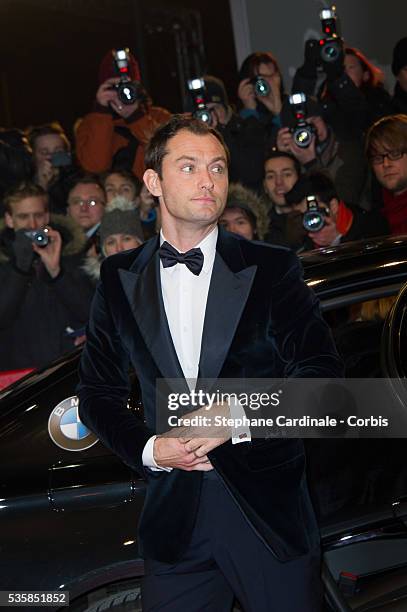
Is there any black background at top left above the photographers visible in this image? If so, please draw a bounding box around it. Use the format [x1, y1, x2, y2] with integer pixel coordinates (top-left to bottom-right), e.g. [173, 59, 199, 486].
[0, 0, 236, 132]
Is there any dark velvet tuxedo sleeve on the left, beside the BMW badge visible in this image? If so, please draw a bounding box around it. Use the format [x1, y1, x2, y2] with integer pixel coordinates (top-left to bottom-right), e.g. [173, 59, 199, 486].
[78, 270, 154, 474]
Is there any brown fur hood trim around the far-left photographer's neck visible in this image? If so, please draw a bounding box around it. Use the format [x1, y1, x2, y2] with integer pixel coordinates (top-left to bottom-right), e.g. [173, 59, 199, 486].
[0, 214, 86, 264]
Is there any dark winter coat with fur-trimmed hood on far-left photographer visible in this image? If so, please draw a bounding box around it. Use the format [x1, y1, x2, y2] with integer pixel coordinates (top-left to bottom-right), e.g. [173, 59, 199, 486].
[0, 216, 93, 371]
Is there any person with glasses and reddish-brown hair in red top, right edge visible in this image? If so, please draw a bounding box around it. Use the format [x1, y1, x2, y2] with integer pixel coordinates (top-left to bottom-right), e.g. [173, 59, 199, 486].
[366, 114, 407, 235]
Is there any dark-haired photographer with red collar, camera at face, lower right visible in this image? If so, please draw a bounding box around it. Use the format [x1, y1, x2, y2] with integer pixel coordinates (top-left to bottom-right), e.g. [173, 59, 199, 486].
[285, 172, 389, 251]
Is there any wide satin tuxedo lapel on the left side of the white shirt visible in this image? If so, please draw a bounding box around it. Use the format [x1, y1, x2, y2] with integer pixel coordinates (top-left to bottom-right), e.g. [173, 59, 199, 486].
[119, 240, 188, 390]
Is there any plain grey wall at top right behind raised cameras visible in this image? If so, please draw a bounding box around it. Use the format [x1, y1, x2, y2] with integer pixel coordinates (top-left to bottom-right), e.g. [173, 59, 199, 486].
[242, 0, 407, 92]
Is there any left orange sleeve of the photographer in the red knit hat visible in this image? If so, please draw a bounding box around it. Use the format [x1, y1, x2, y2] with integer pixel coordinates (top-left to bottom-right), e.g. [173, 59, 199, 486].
[76, 112, 114, 173]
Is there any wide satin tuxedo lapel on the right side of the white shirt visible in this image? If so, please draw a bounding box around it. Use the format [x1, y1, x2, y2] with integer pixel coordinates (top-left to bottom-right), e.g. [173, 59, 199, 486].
[199, 229, 257, 379]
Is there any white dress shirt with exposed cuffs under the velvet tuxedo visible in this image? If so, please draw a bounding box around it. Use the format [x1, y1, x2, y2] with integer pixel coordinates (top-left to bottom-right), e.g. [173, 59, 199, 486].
[142, 226, 251, 471]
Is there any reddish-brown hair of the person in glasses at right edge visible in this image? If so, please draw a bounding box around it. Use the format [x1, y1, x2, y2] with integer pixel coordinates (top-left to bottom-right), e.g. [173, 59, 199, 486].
[366, 114, 407, 157]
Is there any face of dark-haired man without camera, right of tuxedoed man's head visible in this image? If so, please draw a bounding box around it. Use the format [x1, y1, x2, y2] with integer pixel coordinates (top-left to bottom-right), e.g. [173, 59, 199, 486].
[263, 157, 299, 207]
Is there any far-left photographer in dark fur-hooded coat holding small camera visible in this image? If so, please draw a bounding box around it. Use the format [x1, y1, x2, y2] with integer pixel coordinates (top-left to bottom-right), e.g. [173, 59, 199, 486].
[0, 183, 93, 370]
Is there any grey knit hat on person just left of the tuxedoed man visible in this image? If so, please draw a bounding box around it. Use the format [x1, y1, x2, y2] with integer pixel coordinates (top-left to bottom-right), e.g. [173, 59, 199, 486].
[99, 196, 144, 248]
